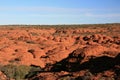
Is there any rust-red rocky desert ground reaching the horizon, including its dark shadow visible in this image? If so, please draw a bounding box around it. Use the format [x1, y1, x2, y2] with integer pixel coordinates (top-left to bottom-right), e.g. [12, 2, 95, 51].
[0, 24, 120, 80]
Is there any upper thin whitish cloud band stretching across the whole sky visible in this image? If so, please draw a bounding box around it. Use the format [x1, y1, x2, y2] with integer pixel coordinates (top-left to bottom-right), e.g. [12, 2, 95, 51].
[0, 6, 120, 12]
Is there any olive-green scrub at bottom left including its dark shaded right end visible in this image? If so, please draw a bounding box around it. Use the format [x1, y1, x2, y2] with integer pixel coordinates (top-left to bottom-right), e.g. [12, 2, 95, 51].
[0, 64, 41, 80]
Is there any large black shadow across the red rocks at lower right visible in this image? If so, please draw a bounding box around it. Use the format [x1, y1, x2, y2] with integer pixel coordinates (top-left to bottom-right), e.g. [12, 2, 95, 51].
[50, 54, 120, 73]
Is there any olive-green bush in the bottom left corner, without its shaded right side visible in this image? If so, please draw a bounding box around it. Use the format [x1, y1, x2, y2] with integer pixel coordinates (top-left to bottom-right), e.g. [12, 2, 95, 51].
[0, 64, 30, 80]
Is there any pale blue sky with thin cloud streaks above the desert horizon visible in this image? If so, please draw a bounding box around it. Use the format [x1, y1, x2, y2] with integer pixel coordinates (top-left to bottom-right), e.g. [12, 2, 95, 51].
[0, 0, 120, 25]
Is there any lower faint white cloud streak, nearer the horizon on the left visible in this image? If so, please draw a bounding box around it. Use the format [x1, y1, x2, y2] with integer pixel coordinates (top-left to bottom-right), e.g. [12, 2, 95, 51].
[0, 14, 83, 19]
